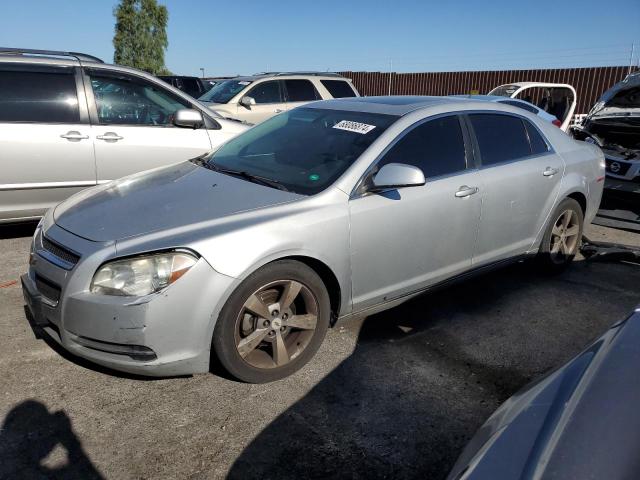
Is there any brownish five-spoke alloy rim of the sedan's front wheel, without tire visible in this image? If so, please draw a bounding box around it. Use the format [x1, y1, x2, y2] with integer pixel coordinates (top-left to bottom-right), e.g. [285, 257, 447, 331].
[235, 280, 319, 369]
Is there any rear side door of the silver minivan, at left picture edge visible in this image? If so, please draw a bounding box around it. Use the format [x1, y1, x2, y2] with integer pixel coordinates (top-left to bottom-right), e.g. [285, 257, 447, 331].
[0, 63, 96, 220]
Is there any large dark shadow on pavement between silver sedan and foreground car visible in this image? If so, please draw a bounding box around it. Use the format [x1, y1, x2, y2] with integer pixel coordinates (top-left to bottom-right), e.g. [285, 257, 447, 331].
[229, 261, 640, 479]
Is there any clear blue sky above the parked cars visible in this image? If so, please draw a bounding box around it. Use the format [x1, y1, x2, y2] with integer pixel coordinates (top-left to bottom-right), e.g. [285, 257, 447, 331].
[0, 0, 640, 76]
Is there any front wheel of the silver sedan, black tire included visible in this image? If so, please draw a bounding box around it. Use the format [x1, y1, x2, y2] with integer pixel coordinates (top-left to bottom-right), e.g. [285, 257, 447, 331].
[212, 260, 331, 383]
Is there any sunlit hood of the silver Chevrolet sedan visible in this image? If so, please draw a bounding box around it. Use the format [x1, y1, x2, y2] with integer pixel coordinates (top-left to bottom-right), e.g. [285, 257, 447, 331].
[53, 162, 304, 242]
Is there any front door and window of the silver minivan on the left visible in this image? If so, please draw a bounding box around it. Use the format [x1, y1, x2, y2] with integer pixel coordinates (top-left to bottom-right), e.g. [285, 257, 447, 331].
[85, 69, 211, 182]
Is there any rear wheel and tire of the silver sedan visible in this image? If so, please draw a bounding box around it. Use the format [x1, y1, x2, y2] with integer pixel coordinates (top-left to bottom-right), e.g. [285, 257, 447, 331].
[536, 198, 584, 273]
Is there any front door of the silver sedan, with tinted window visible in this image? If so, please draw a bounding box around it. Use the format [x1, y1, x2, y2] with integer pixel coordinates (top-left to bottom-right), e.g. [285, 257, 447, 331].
[350, 115, 481, 311]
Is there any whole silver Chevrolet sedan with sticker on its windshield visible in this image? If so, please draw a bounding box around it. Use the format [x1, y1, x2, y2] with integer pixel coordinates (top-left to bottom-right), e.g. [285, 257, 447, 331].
[22, 97, 604, 382]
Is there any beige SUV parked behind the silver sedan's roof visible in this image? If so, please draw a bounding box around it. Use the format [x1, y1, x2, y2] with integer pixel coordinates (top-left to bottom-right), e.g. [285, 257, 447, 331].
[199, 72, 360, 124]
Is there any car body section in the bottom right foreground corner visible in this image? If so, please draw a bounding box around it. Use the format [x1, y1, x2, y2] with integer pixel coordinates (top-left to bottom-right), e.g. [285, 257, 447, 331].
[448, 310, 640, 480]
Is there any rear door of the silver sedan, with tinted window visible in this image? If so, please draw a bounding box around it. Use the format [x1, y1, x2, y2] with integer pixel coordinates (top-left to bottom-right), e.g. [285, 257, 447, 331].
[467, 112, 564, 266]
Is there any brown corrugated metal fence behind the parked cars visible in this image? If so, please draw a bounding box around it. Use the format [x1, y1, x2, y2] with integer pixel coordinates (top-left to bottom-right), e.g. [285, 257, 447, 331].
[340, 67, 629, 114]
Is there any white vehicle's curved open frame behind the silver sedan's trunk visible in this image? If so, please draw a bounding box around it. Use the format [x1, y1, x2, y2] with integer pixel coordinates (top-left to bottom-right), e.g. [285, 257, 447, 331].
[487, 82, 577, 132]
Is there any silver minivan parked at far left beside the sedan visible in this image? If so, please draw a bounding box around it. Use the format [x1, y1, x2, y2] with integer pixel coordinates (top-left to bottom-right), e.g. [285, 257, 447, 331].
[0, 48, 247, 223]
